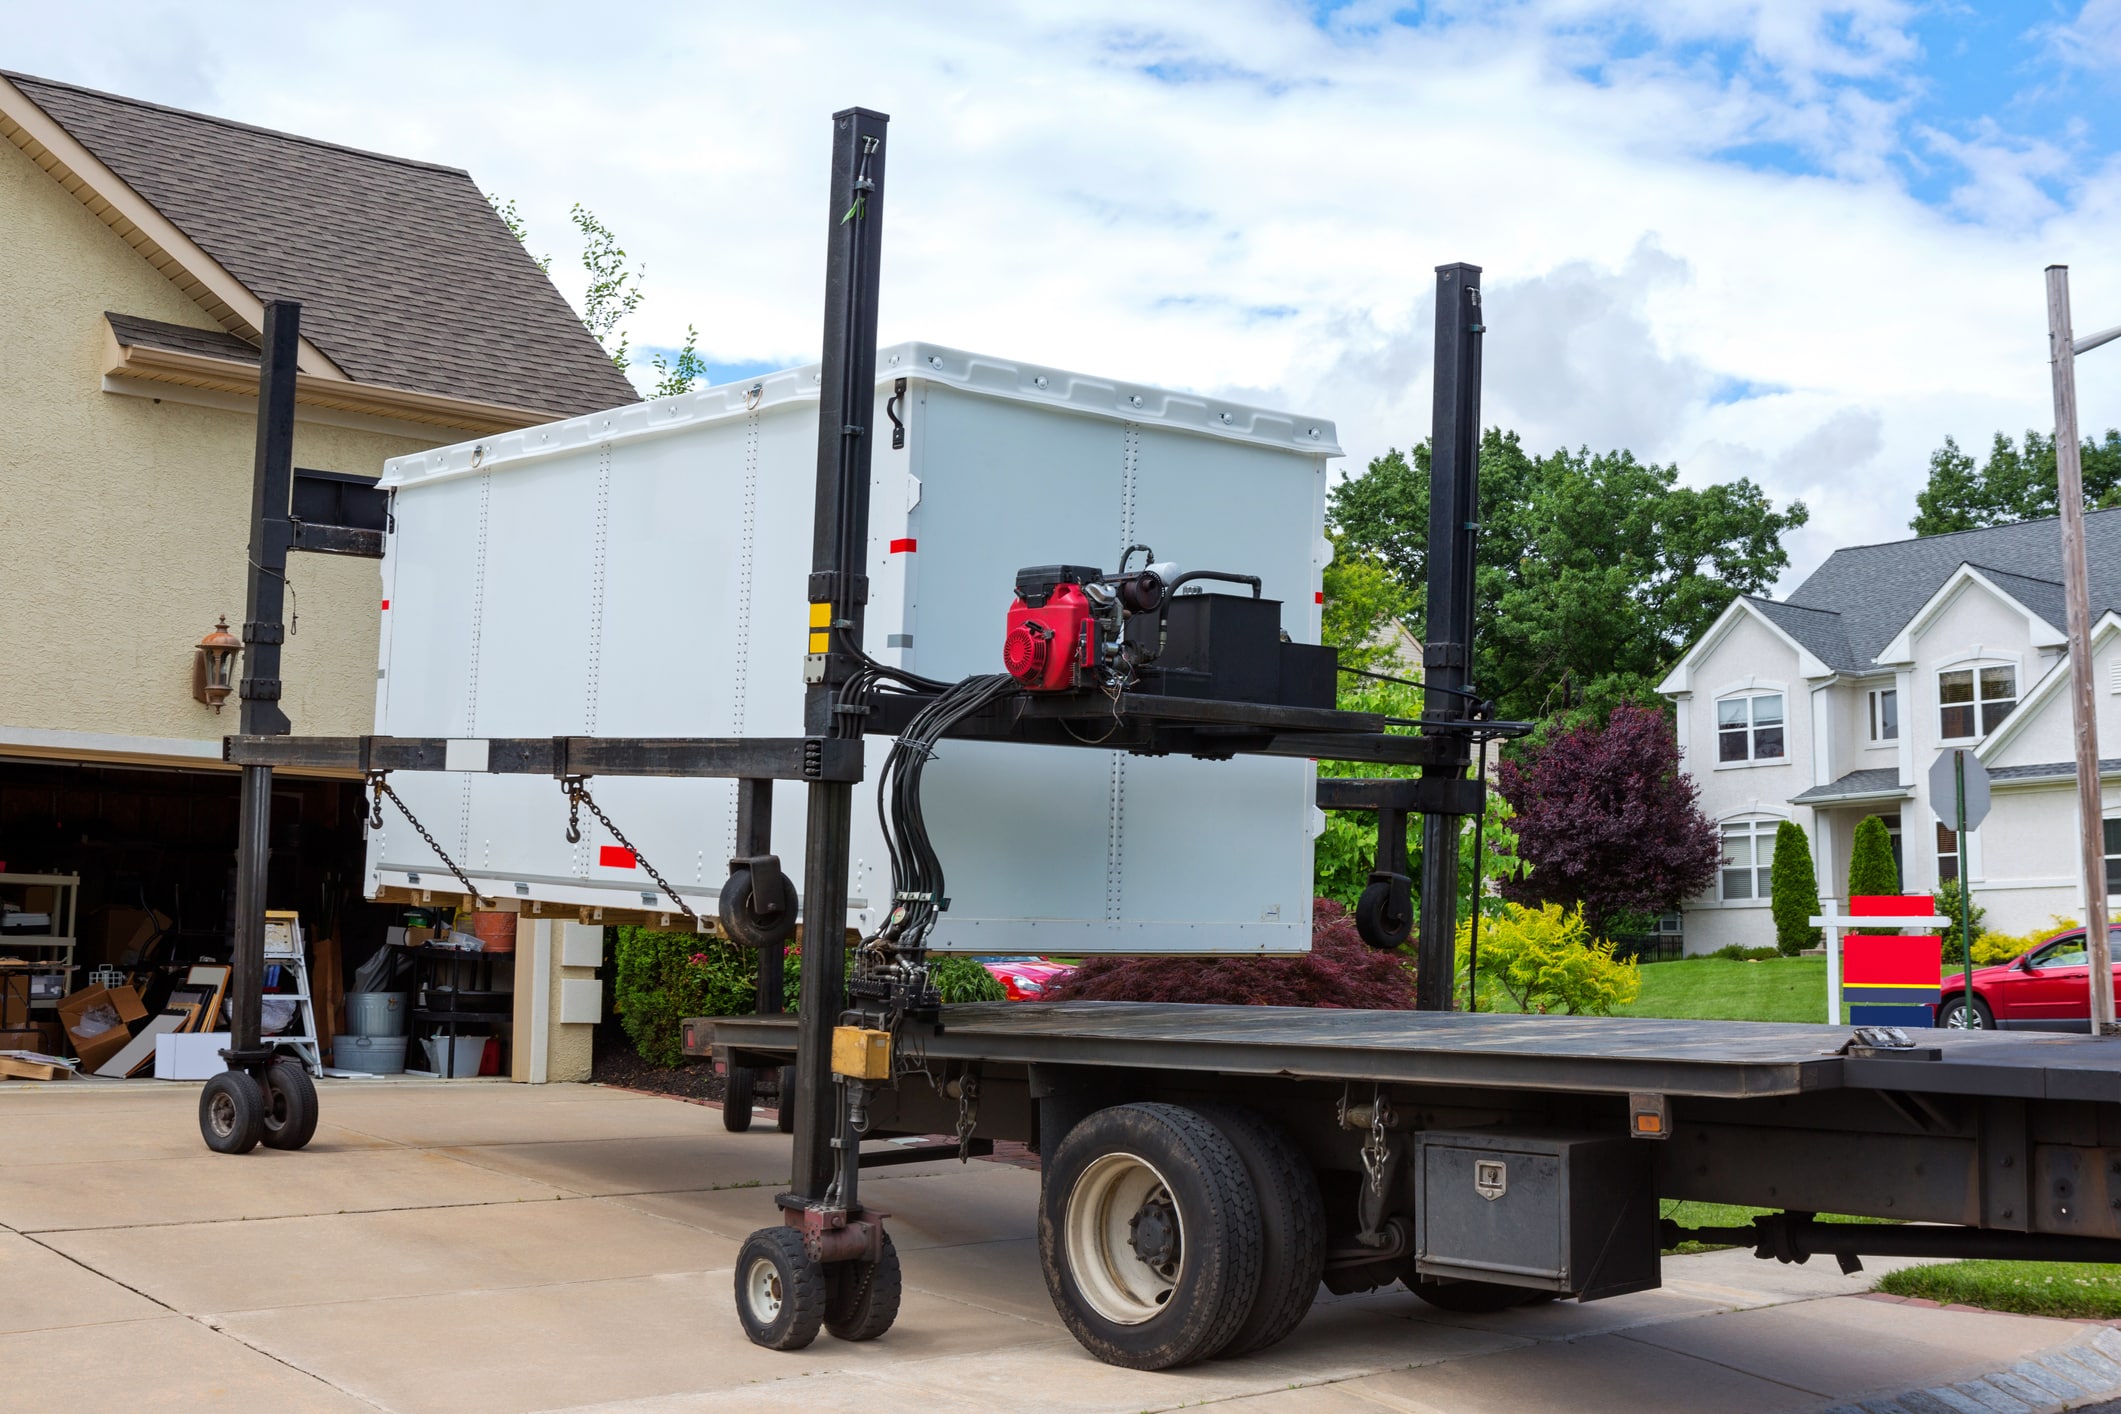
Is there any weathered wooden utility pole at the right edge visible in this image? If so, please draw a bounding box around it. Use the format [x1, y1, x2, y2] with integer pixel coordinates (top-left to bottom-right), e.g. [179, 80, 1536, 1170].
[2044, 265, 2121, 1037]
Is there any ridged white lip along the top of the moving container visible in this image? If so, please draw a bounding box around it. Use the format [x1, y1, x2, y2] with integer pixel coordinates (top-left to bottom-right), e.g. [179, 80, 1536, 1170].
[380, 341, 1340, 490]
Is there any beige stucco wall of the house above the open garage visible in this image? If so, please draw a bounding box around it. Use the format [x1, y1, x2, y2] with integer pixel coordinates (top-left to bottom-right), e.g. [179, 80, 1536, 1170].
[0, 142, 436, 759]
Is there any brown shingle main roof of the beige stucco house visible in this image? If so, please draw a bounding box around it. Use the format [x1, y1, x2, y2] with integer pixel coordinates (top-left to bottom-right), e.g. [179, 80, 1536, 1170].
[6, 74, 638, 416]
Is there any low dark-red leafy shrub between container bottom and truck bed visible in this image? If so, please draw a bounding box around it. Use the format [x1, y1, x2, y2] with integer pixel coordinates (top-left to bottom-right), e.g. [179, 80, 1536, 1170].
[1046, 899, 1415, 1011]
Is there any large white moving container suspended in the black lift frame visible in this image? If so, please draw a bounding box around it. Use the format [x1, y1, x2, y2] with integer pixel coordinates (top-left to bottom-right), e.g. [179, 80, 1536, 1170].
[369, 343, 1338, 954]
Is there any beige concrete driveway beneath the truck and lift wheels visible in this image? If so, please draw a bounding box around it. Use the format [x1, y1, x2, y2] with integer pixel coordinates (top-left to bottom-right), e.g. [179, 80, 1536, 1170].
[0, 1081, 2121, 1414]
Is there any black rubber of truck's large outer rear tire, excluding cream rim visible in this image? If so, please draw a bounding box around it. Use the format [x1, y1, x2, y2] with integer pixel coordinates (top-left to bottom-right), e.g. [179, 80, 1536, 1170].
[1039, 1104, 1260, 1369]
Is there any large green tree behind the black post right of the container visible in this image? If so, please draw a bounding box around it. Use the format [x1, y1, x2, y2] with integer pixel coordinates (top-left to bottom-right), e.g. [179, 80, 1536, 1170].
[1328, 428, 1809, 719]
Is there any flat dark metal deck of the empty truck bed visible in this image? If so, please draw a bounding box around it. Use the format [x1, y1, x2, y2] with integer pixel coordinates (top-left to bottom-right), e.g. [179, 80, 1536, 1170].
[713, 1003, 2121, 1100]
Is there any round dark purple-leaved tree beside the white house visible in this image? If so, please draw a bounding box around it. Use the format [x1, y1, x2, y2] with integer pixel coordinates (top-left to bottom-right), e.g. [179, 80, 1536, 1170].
[1497, 706, 1722, 937]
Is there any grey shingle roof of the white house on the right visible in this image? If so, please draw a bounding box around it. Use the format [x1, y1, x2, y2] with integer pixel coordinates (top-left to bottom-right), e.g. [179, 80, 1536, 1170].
[1786, 509, 2121, 668]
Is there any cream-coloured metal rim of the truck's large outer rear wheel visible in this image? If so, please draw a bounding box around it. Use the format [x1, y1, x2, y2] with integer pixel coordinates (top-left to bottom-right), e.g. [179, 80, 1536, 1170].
[1063, 1153, 1186, 1325]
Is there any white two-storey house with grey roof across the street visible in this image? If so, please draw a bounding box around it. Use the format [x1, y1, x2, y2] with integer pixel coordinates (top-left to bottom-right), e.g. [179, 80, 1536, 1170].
[1659, 511, 2121, 952]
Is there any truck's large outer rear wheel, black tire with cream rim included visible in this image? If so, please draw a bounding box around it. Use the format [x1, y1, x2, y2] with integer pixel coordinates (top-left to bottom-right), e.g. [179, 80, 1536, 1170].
[1039, 1104, 1262, 1369]
